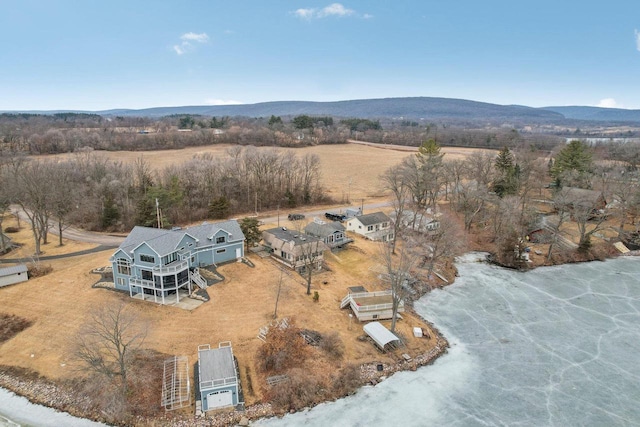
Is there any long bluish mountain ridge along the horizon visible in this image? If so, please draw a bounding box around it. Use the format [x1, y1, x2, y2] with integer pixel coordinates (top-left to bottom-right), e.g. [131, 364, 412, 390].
[2, 97, 640, 124]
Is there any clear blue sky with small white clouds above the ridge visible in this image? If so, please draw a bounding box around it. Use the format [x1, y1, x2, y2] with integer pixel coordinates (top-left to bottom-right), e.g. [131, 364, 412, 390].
[0, 0, 640, 110]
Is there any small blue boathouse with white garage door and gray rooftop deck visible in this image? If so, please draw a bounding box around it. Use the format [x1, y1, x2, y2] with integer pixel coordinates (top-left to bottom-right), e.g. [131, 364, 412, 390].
[198, 341, 243, 412]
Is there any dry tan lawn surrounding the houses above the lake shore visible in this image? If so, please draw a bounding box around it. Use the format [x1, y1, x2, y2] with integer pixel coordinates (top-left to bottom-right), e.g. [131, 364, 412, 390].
[0, 216, 435, 403]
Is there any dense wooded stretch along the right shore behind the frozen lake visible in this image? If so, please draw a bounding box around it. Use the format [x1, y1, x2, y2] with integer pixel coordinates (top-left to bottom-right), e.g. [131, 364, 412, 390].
[380, 140, 640, 273]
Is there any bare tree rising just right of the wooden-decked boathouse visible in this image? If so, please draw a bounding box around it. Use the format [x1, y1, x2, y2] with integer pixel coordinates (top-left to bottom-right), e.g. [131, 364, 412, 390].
[379, 243, 417, 332]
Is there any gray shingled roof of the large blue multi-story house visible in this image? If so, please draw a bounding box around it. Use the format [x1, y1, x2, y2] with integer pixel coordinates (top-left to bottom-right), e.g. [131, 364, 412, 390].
[119, 220, 244, 256]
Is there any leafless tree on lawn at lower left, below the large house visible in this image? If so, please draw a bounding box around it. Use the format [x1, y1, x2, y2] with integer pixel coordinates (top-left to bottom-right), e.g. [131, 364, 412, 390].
[74, 303, 147, 393]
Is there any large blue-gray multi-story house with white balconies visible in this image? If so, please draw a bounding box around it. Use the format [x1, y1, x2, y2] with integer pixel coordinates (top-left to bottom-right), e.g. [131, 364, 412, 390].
[110, 220, 244, 304]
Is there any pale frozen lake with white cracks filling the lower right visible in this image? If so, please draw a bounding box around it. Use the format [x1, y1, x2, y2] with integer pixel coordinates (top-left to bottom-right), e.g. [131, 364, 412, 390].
[260, 257, 640, 427]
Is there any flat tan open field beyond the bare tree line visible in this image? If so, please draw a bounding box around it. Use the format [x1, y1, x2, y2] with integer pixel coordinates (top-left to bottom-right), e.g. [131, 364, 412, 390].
[38, 144, 493, 203]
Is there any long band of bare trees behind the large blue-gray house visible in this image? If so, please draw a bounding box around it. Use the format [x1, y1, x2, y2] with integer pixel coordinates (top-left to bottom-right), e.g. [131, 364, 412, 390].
[0, 146, 324, 252]
